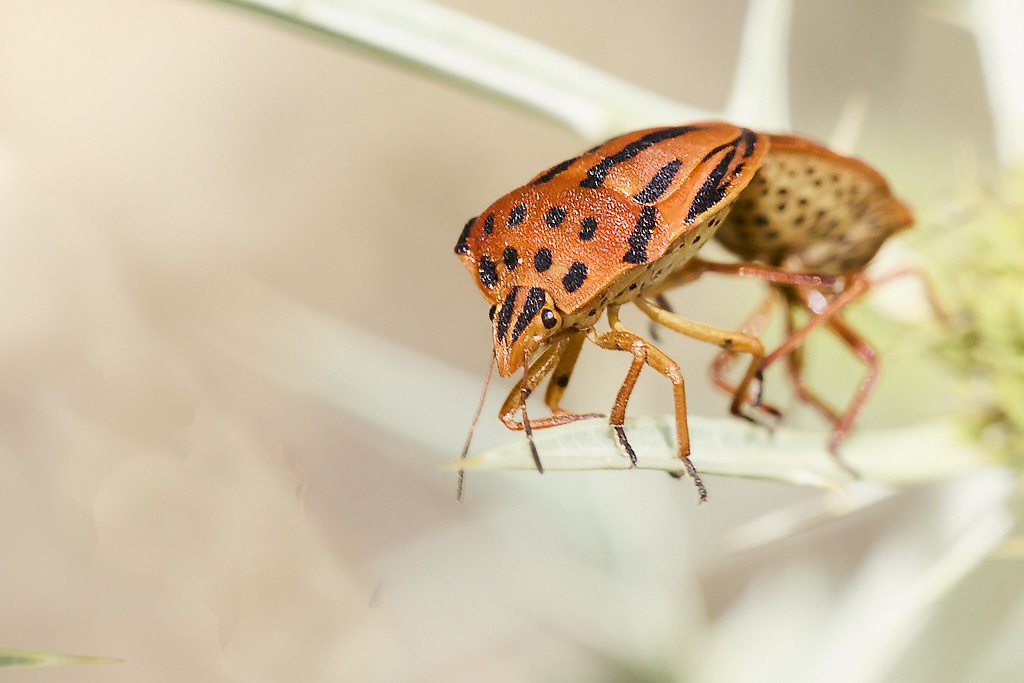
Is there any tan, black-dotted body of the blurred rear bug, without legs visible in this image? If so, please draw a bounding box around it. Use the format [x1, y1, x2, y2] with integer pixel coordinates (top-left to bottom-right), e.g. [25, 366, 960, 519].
[717, 135, 913, 274]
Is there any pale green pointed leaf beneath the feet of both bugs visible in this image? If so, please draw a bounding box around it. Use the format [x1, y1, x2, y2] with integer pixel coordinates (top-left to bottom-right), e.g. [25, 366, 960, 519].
[444, 416, 987, 487]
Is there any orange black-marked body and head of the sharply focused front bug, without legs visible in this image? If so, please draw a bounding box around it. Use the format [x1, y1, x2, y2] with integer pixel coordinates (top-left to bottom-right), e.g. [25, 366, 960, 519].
[456, 122, 768, 376]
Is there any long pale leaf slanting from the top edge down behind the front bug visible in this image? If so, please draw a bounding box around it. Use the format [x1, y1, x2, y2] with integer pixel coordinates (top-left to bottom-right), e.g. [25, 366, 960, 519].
[206, 0, 704, 139]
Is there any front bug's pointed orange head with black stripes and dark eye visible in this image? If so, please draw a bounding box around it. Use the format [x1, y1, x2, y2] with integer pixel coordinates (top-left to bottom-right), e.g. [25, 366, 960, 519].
[490, 287, 562, 377]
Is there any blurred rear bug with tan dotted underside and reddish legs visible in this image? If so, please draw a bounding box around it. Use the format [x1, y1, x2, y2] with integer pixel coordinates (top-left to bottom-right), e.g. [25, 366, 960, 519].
[690, 135, 913, 455]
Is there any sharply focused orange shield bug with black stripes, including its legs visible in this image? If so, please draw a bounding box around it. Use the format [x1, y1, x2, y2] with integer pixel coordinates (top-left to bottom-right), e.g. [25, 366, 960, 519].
[455, 122, 769, 500]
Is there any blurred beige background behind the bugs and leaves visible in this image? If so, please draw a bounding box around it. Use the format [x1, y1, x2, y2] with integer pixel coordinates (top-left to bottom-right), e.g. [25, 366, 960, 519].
[0, 0, 993, 682]
